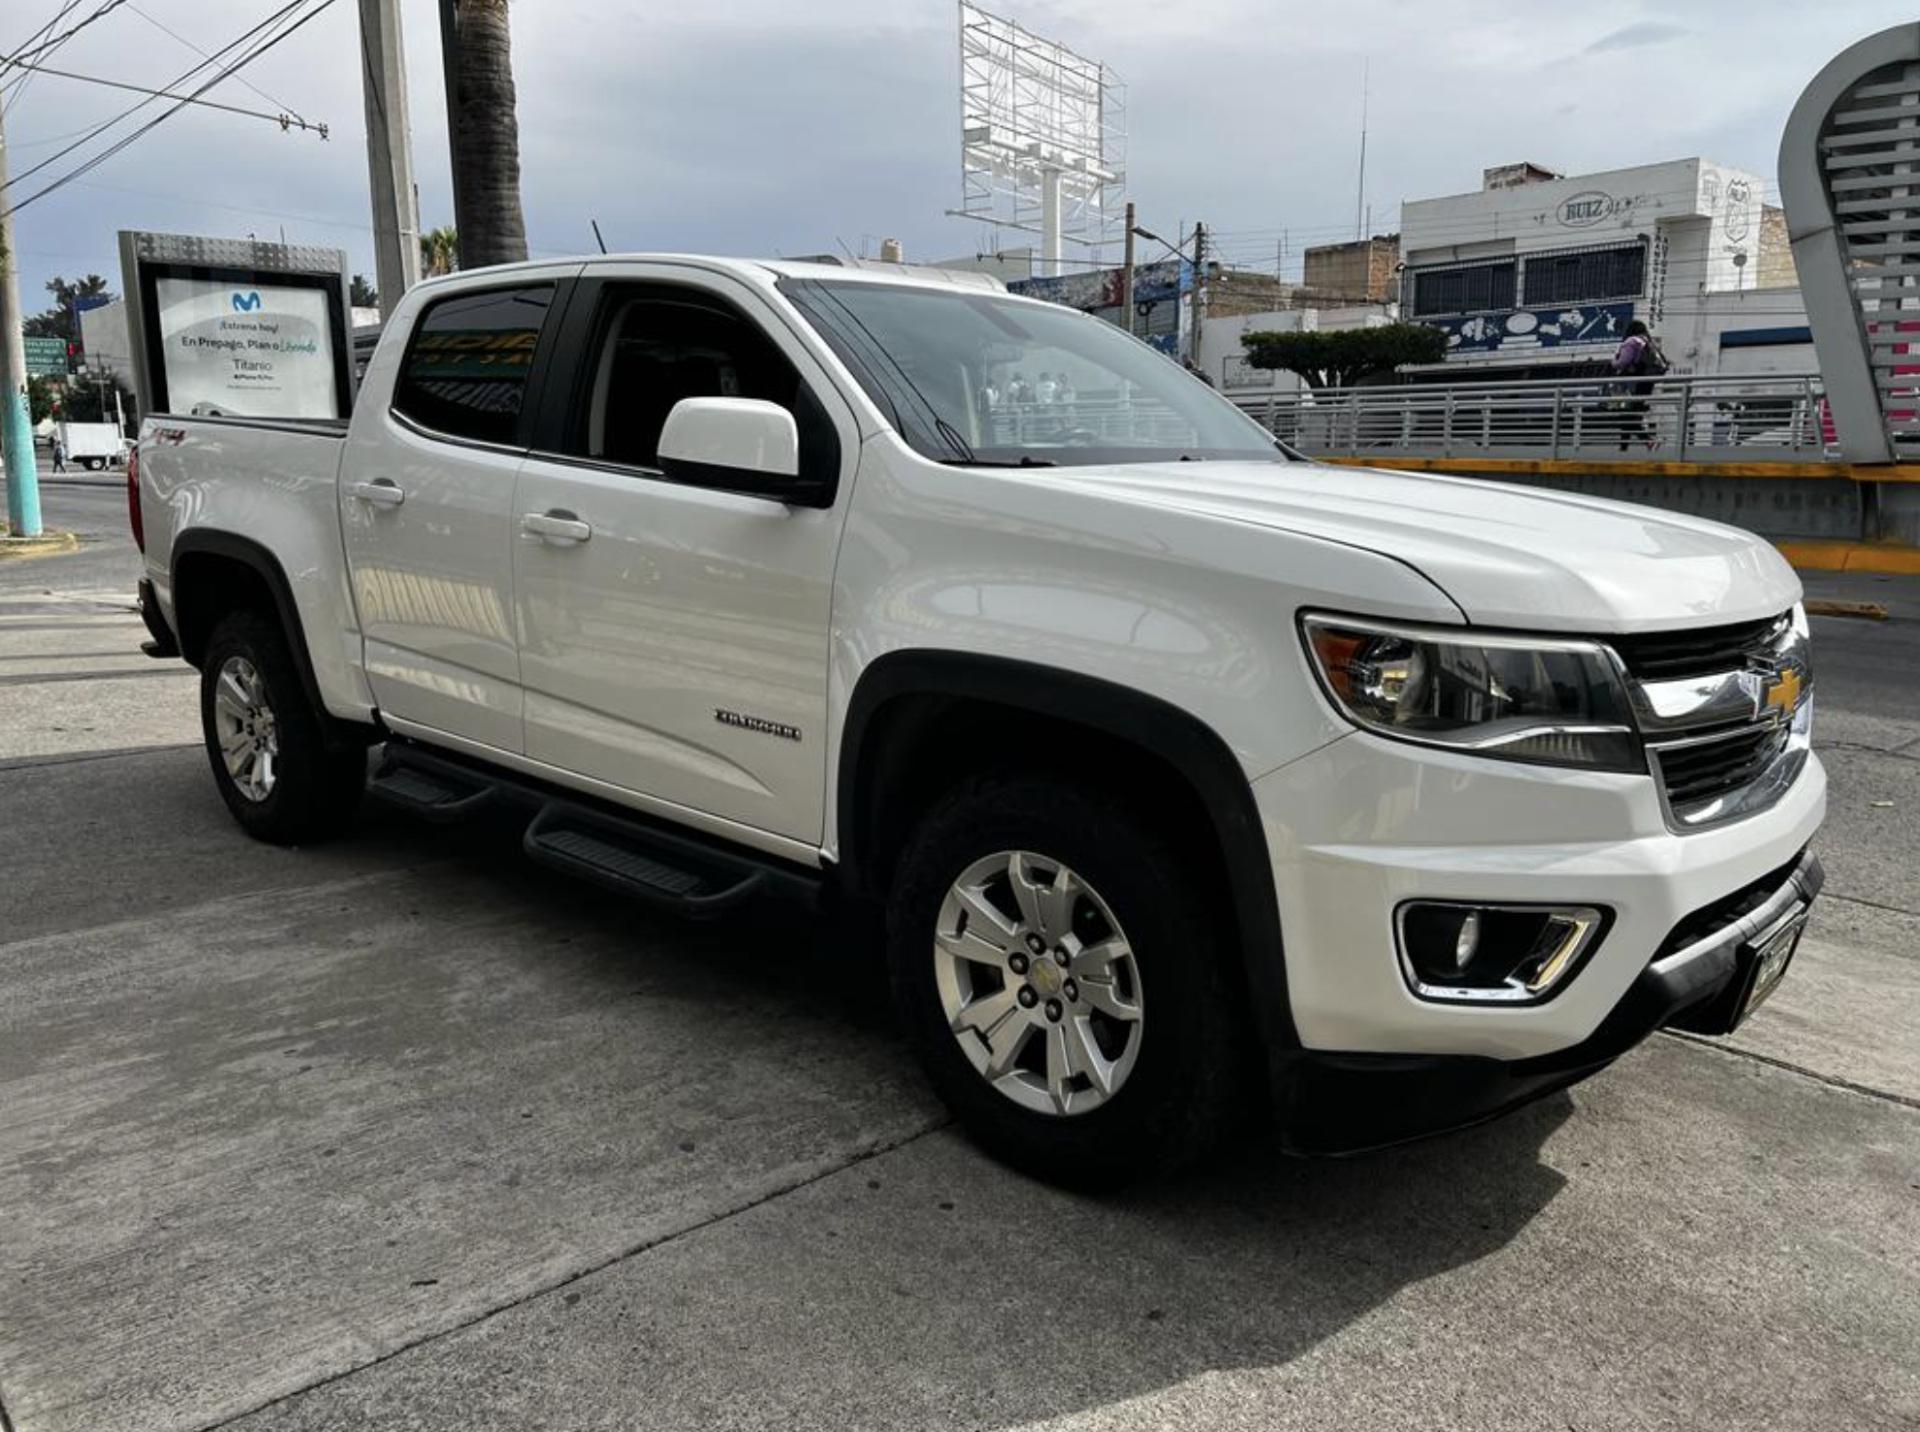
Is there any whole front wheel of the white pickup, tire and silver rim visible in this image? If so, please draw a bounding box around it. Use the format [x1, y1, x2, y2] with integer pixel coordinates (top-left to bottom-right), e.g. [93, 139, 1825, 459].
[889, 779, 1240, 1188]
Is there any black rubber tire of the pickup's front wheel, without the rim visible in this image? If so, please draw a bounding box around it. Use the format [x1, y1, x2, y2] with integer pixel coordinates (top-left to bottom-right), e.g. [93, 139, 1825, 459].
[887, 777, 1246, 1190]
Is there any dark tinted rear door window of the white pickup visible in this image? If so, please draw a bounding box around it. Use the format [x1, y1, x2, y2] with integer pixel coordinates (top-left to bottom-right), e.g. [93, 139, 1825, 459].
[394, 284, 553, 443]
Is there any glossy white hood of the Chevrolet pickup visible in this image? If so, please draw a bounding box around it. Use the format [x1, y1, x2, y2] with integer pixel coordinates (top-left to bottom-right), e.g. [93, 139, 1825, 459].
[1033, 463, 1801, 632]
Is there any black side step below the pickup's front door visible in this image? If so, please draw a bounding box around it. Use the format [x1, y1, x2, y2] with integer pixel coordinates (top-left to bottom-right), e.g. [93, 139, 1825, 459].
[524, 802, 768, 919]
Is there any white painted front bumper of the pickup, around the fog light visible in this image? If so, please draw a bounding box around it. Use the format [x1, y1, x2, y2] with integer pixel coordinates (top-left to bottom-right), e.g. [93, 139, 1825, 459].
[1254, 733, 1826, 1062]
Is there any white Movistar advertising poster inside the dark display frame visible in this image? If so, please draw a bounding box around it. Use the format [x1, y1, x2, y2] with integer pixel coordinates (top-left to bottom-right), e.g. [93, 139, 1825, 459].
[154, 276, 344, 418]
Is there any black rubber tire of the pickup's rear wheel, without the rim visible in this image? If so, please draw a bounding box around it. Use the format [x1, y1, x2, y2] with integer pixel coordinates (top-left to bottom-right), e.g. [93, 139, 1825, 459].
[200, 610, 367, 845]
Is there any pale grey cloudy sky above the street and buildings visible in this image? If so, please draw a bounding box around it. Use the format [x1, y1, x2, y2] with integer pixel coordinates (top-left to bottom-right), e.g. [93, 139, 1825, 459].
[0, 0, 1914, 311]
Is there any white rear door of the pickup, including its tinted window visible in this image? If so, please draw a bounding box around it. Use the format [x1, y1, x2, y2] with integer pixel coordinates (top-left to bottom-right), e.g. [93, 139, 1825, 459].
[340, 269, 578, 752]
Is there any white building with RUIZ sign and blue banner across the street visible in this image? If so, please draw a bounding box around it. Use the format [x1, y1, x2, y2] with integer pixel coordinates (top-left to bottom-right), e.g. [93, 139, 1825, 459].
[1400, 159, 1816, 378]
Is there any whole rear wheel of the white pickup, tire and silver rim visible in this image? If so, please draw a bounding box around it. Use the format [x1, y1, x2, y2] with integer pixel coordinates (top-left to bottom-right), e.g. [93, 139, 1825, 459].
[200, 612, 367, 845]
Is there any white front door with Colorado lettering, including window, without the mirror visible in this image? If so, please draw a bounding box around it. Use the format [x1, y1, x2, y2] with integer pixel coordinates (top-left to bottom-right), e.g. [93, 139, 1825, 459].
[515, 265, 858, 845]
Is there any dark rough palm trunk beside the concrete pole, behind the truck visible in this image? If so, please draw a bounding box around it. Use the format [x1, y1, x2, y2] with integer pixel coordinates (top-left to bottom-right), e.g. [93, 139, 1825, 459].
[440, 0, 526, 269]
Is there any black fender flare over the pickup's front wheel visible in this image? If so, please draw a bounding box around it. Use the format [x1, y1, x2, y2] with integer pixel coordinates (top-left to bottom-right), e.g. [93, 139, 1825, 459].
[835, 651, 1300, 1058]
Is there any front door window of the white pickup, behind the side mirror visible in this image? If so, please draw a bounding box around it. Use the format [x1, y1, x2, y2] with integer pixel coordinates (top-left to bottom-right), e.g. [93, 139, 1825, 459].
[566, 288, 839, 484]
